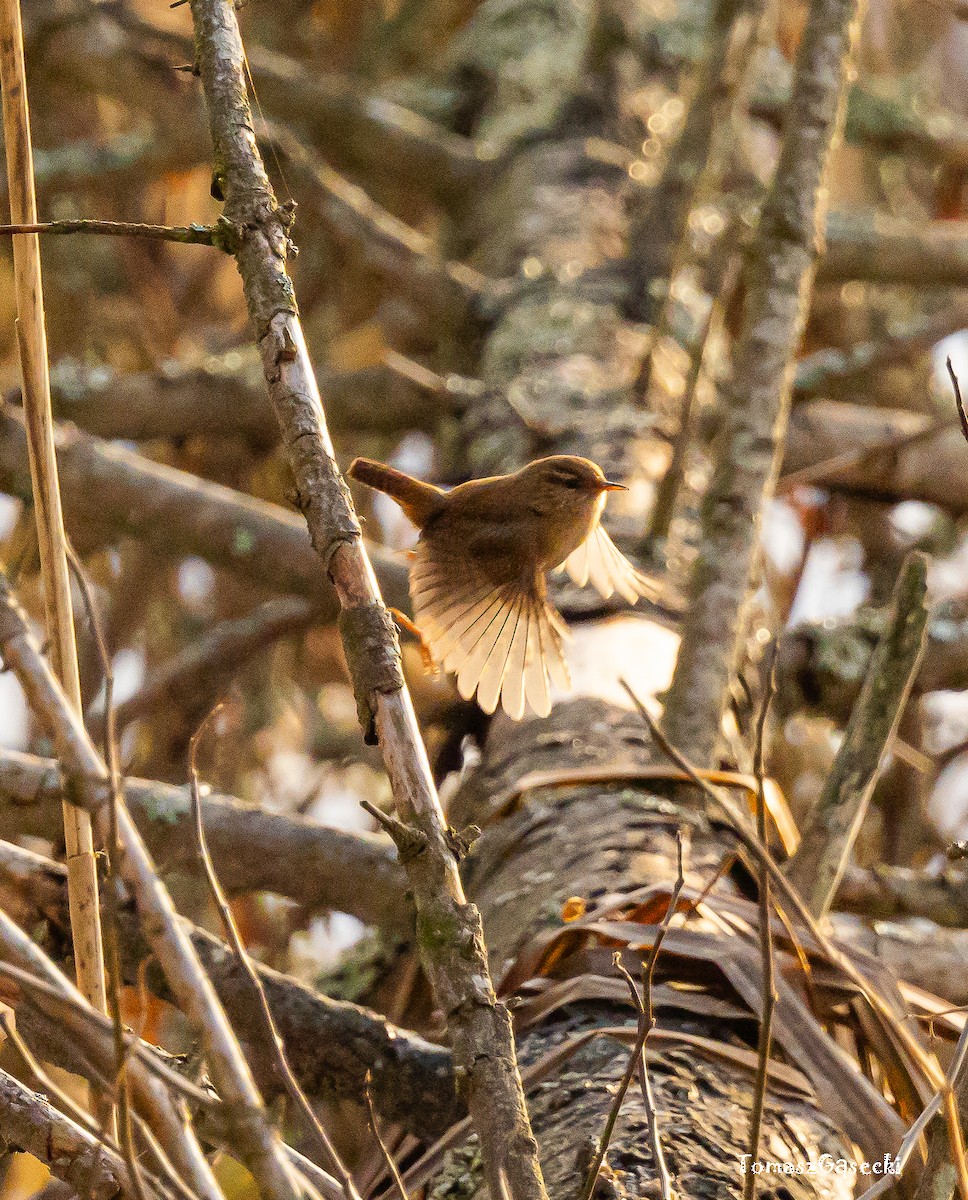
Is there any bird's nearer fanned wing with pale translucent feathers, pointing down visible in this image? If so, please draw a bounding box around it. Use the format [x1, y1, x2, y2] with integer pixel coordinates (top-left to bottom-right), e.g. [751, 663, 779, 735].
[410, 539, 570, 721]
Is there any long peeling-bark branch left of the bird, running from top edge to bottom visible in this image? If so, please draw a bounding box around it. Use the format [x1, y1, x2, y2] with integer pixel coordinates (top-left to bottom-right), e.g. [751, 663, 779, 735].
[182, 0, 546, 1200]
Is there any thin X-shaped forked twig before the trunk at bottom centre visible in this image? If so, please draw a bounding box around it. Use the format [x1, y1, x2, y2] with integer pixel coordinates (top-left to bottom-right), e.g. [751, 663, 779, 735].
[579, 832, 685, 1200]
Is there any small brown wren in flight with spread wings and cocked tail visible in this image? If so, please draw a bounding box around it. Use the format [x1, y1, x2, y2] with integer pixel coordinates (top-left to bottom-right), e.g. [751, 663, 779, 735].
[349, 455, 659, 720]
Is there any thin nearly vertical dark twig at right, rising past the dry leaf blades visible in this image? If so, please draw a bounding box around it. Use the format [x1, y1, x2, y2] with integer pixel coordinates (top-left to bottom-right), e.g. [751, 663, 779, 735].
[742, 638, 780, 1200]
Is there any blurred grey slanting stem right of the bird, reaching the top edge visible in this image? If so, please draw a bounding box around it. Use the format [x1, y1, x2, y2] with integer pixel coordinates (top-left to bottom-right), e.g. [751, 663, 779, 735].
[666, 0, 858, 762]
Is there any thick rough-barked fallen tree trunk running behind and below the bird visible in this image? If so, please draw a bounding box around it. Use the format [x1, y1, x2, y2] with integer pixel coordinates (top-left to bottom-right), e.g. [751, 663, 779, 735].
[388, 0, 900, 1196]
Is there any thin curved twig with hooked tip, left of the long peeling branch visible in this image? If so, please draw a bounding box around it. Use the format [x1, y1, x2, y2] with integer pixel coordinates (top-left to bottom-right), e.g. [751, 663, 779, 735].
[188, 703, 361, 1200]
